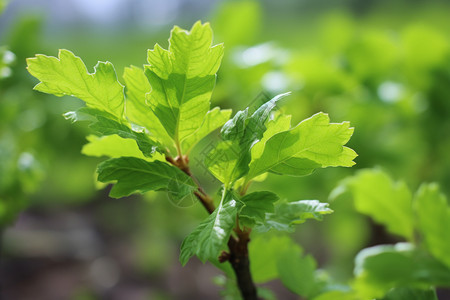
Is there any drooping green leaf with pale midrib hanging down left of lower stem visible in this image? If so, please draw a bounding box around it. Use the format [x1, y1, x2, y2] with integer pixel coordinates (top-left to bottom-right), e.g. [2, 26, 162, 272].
[180, 190, 241, 266]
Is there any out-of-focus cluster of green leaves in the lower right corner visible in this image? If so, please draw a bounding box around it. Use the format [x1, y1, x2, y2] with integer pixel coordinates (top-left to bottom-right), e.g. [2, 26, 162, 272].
[317, 169, 450, 300]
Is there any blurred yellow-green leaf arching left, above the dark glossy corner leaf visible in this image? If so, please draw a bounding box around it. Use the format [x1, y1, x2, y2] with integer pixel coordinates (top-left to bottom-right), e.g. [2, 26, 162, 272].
[338, 169, 413, 240]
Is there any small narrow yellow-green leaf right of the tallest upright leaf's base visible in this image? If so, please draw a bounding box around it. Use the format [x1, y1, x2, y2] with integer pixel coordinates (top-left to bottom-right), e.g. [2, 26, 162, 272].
[181, 107, 231, 153]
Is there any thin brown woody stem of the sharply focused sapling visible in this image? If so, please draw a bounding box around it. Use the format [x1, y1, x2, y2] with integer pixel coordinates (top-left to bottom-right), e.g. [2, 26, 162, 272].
[166, 156, 258, 300]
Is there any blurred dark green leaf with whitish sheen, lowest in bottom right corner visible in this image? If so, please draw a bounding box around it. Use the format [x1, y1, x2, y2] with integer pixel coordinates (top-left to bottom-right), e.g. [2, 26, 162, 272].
[353, 243, 450, 299]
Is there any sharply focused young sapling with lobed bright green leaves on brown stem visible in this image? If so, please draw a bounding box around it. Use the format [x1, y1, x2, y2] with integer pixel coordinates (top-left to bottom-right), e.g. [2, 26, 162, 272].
[27, 22, 356, 299]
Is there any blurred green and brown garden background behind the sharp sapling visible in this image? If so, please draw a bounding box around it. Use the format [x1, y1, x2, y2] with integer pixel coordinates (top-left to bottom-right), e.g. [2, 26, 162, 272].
[0, 0, 450, 300]
